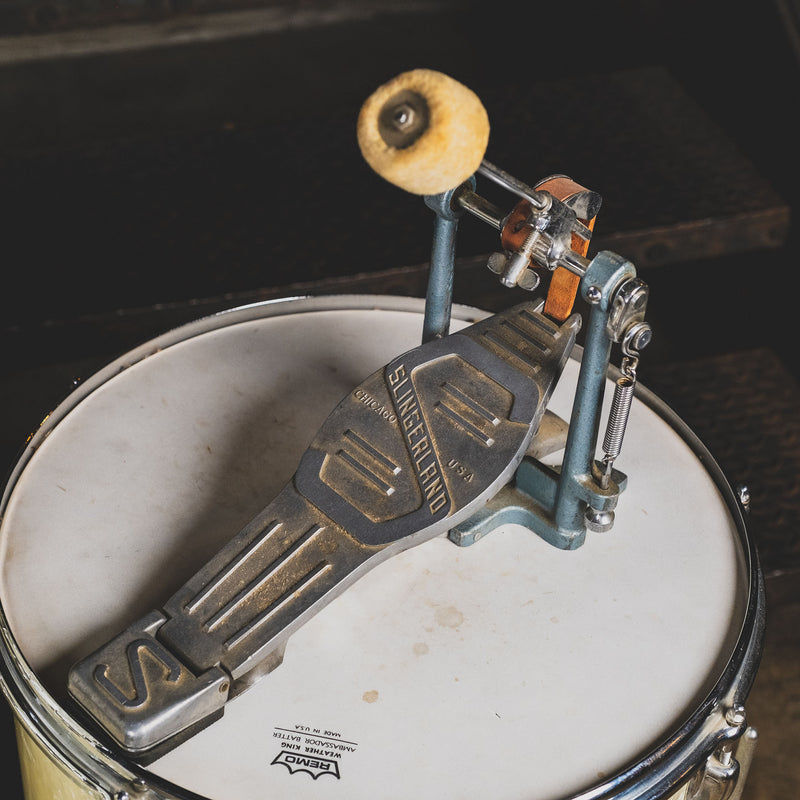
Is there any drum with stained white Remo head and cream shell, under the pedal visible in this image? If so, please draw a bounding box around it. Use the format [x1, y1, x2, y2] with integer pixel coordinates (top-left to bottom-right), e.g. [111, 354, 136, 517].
[0, 297, 763, 800]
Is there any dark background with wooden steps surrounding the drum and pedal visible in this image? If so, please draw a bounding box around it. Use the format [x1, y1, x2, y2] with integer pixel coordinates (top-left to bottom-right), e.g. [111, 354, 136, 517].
[0, 0, 800, 800]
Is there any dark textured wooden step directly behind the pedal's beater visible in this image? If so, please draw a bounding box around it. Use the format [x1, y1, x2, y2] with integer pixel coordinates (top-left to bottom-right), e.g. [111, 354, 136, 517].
[0, 62, 789, 372]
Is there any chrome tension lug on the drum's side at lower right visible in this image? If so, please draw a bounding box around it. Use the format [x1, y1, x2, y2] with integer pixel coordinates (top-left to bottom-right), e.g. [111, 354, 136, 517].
[686, 706, 758, 800]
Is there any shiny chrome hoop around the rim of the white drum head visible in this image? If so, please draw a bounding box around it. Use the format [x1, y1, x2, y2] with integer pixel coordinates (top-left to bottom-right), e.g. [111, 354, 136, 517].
[0, 295, 765, 800]
